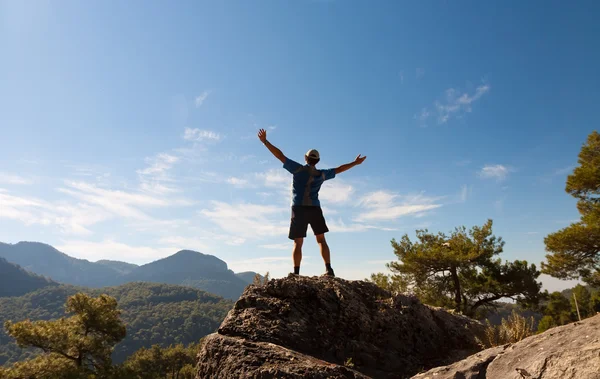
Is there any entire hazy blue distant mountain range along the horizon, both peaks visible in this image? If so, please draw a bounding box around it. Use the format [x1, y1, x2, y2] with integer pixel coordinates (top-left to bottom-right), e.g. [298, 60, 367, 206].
[0, 242, 254, 300]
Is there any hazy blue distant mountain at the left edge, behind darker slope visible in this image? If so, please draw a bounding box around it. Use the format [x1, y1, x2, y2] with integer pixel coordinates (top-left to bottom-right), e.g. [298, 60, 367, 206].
[0, 242, 121, 287]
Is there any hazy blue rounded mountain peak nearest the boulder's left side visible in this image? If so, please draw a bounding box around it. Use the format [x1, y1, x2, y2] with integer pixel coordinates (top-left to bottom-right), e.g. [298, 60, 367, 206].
[121, 250, 248, 300]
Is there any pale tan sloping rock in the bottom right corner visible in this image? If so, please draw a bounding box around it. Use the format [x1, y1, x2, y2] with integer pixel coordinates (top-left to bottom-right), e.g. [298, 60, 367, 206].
[413, 315, 600, 379]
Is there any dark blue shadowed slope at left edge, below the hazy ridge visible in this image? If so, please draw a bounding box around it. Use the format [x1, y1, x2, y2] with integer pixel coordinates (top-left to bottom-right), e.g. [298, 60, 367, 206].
[0, 258, 58, 297]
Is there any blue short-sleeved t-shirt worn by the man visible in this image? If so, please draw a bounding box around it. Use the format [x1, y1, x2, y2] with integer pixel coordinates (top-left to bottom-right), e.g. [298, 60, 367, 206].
[283, 158, 335, 207]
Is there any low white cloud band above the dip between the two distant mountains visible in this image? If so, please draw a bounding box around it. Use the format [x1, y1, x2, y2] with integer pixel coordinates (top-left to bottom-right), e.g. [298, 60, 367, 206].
[56, 239, 177, 264]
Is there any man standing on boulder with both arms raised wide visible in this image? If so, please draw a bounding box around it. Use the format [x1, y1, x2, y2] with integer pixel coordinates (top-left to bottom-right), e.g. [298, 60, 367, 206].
[258, 129, 367, 276]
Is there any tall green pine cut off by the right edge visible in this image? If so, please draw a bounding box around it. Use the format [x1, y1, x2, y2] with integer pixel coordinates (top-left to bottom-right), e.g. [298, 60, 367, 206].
[542, 131, 600, 285]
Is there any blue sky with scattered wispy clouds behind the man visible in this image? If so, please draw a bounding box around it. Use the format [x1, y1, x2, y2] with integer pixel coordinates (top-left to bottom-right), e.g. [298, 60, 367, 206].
[0, 0, 600, 289]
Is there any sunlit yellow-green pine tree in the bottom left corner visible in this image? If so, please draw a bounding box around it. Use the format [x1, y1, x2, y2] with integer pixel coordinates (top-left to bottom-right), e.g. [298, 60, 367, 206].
[5, 293, 126, 379]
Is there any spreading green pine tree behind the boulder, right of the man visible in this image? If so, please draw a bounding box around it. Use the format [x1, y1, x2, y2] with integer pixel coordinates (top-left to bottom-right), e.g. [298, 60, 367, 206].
[371, 220, 541, 316]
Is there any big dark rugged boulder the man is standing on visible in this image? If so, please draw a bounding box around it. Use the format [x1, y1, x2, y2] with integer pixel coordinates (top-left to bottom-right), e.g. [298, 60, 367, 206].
[197, 275, 481, 379]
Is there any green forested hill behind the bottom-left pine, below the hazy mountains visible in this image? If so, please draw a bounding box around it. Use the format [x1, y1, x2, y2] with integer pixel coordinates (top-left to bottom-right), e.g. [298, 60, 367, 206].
[0, 283, 233, 366]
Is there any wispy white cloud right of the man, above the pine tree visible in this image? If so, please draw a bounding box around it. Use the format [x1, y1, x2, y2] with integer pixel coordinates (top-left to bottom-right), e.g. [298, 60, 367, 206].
[356, 191, 442, 221]
